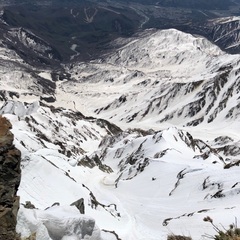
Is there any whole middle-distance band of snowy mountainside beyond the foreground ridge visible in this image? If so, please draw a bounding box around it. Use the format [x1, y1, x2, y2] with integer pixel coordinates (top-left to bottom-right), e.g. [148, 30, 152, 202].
[0, 29, 239, 133]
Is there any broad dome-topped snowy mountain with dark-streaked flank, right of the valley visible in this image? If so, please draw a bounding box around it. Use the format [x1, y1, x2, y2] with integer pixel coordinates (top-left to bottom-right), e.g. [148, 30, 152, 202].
[63, 30, 239, 132]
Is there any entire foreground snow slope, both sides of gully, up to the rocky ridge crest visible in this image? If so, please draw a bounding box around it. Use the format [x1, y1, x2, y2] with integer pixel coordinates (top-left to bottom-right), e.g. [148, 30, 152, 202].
[2, 102, 240, 240]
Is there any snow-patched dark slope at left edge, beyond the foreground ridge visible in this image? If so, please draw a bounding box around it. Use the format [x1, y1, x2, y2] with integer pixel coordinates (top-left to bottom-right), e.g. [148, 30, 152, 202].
[0, 36, 56, 102]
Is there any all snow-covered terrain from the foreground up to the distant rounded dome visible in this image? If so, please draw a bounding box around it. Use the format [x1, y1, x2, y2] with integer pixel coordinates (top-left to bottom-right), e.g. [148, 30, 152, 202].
[0, 29, 240, 240]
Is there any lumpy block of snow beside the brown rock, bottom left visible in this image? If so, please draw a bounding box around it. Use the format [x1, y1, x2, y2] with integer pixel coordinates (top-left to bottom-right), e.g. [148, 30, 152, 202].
[18, 206, 101, 240]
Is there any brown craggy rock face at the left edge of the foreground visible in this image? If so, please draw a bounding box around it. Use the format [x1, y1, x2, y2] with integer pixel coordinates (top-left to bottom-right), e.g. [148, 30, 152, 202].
[0, 116, 21, 240]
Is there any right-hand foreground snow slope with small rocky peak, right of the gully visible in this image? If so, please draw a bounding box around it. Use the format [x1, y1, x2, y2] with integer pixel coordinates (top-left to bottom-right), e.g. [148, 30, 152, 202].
[90, 128, 240, 239]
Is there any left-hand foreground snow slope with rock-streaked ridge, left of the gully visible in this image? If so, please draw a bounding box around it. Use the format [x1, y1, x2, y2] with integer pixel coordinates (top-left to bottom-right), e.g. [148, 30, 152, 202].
[1, 102, 124, 240]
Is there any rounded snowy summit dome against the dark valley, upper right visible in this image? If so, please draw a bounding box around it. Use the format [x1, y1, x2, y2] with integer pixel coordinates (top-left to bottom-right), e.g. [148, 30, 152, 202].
[106, 29, 223, 72]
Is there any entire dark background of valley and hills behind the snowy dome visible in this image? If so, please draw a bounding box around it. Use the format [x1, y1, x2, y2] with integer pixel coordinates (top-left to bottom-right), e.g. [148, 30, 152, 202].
[0, 0, 240, 68]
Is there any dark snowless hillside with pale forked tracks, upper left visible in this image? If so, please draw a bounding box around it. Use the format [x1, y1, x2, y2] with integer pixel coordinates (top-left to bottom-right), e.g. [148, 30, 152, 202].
[1, 1, 142, 65]
